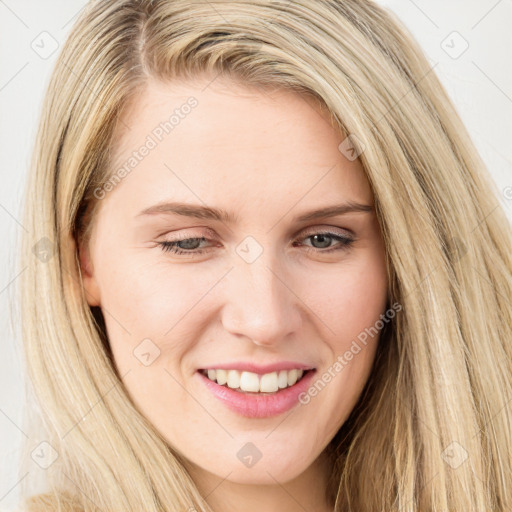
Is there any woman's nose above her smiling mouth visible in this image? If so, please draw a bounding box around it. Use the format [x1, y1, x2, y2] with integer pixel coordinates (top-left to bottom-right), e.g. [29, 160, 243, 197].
[222, 253, 302, 346]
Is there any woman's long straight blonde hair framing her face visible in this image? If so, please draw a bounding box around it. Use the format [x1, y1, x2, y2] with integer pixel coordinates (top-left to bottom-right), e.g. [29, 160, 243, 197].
[16, 0, 512, 512]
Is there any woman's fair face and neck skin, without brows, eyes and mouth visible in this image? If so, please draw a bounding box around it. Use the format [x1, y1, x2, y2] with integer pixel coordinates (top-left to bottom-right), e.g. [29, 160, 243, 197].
[80, 77, 388, 512]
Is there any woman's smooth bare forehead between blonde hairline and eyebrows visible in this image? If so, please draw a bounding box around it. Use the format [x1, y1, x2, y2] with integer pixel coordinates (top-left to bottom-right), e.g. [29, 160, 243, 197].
[110, 77, 372, 213]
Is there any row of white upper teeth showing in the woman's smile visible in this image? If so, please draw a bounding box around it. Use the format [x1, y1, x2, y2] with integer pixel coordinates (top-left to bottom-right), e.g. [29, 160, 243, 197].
[203, 369, 304, 393]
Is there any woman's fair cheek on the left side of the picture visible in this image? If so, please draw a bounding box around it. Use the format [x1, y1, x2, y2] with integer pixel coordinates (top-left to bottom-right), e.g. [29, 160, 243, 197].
[95, 258, 203, 425]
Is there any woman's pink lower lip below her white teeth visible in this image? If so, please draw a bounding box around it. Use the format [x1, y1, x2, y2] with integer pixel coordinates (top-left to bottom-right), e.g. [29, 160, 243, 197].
[196, 370, 316, 418]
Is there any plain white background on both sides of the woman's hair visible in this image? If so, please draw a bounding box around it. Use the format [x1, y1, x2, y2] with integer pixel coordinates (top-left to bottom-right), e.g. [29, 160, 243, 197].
[0, 0, 512, 510]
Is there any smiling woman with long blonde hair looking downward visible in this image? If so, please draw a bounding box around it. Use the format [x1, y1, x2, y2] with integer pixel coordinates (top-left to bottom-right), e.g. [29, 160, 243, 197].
[16, 0, 512, 512]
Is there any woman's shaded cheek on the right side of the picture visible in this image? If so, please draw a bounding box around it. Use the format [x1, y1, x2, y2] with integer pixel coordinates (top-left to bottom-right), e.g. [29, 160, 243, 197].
[303, 255, 388, 438]
